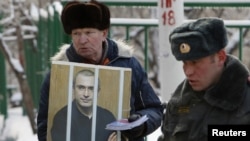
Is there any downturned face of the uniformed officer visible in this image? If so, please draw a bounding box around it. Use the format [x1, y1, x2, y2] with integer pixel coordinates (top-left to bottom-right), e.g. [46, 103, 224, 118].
[183, 54, 224, 91]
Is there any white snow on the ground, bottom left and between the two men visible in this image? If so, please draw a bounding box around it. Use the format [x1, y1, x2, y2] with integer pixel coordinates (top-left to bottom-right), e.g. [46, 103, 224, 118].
[0, 107, 161, 141]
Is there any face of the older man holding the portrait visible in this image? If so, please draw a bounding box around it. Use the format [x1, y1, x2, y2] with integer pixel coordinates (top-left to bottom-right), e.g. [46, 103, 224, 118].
[71, 28, 107, 62]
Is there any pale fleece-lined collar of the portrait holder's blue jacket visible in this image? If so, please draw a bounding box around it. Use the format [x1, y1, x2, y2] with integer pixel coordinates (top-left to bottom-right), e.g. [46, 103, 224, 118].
[50, 39, 133, 63]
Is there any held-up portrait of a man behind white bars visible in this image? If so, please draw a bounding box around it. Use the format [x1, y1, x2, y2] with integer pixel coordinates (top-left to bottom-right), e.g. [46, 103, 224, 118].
[47, 61, 132, 141]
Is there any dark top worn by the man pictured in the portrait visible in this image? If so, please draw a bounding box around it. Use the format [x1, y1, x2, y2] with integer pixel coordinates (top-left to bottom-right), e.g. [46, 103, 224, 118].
[51, 100, 116, 141]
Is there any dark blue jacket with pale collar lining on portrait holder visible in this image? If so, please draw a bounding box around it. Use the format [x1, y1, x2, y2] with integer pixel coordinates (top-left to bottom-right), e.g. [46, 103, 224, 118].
[37, 39, 163, 141]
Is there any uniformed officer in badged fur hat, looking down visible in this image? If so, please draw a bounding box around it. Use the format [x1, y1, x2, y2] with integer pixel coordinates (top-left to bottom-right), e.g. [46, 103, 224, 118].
[159, 17, 250, 141]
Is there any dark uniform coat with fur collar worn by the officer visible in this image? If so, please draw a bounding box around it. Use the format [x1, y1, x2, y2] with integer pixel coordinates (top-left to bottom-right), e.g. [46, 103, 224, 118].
[159, 56, 250, 141]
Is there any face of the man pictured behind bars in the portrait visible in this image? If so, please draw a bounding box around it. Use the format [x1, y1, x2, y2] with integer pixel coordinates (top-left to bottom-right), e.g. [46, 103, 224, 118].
[74, 74, 95, 107]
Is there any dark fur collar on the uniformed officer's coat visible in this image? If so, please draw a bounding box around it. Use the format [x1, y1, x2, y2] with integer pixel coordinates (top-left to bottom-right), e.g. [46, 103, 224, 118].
[204, 55, 249, 110]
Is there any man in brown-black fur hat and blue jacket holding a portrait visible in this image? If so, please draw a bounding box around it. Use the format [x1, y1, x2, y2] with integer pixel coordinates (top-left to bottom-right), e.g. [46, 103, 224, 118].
[37, 0, 163, 141]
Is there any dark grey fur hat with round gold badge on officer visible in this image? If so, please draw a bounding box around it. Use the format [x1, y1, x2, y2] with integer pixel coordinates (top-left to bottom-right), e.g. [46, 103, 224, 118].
[169, 17, 228, 60]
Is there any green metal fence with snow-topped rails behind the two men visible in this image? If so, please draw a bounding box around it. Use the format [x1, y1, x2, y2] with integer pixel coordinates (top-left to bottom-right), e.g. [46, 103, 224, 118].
[0, 0, 250, 117]
